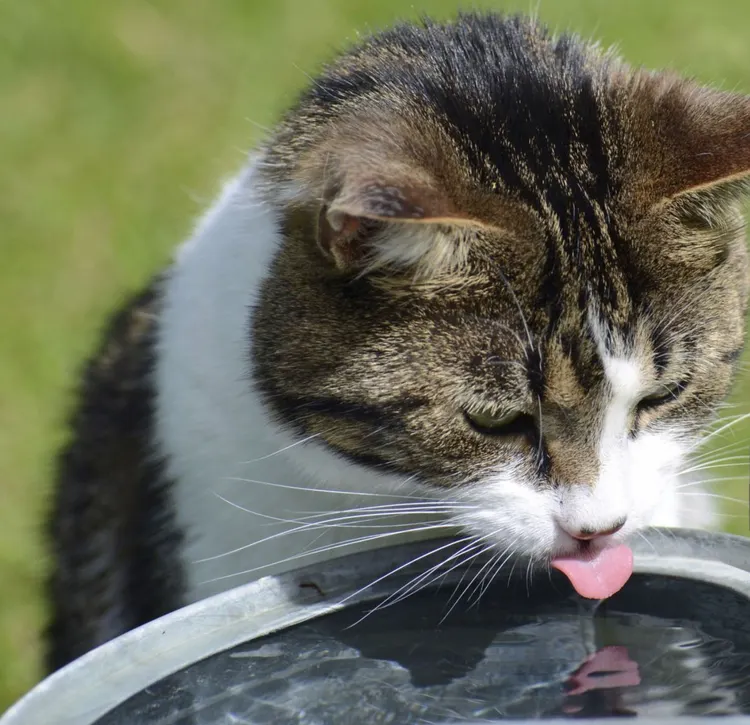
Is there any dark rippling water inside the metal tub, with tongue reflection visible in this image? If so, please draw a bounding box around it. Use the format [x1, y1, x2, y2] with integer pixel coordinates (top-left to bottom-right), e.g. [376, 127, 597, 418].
[97, 576, 750, 725]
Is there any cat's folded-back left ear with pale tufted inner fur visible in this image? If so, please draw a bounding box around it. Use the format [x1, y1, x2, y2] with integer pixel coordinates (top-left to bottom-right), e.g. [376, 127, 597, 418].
[318, 173, 470, 276]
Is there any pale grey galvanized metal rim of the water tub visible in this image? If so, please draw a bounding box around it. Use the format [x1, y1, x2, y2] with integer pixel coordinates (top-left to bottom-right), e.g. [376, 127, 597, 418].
[0, 529, 750, 725]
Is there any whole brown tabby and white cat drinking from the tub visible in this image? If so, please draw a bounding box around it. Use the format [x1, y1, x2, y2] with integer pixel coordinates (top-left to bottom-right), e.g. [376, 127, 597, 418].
[47, 13, 750, 670]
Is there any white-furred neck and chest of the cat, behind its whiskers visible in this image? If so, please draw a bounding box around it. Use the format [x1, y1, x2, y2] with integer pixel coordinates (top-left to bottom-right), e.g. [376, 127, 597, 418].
[155, 160, 434, 600]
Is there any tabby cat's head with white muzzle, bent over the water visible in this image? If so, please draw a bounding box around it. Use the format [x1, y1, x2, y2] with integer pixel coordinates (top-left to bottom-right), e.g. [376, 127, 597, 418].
[254, 15, 750, 584]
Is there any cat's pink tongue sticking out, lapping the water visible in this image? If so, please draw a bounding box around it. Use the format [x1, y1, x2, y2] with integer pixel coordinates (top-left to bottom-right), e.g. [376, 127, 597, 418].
[552, 545, 633, 599]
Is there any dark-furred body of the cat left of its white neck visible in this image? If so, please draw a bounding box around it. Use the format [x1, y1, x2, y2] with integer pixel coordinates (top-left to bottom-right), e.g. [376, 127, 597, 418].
[46, 282, 184, 671]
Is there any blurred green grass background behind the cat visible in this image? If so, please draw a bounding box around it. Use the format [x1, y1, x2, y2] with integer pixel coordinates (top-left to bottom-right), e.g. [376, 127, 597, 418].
[0, 0, 750, 712]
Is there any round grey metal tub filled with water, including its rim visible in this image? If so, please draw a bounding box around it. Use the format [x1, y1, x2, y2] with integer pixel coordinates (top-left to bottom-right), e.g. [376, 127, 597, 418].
[0, 529, 750, 725]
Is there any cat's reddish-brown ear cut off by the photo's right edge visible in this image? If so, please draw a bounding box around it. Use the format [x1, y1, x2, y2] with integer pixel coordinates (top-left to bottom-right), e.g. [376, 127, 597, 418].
[653, 83, 750, 198]
